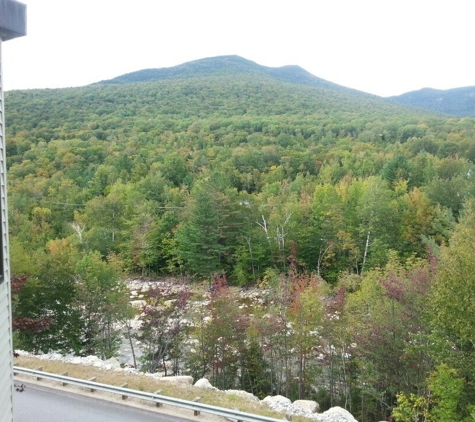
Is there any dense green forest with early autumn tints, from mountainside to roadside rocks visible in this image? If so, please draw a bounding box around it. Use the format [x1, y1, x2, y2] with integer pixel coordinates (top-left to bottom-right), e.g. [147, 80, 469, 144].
[5, 59, 475, 421]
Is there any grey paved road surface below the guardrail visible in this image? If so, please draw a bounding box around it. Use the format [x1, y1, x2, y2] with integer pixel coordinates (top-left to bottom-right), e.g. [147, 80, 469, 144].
[13, 383, 195, 422]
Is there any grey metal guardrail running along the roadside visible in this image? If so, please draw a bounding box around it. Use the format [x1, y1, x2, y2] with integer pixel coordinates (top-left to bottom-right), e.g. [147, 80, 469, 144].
[13, 366, 285, 422]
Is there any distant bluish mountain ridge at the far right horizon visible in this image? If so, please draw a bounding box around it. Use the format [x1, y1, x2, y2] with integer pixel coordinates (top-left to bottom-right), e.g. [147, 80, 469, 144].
[389, 86, 475, 117]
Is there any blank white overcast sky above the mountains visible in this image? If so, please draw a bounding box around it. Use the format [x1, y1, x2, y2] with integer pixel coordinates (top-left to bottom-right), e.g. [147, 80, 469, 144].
[3, 0, 475, 96]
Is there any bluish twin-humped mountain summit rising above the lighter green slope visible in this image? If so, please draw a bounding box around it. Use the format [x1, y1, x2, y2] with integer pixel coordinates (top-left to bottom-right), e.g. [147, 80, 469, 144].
[98, 55, 369, 95]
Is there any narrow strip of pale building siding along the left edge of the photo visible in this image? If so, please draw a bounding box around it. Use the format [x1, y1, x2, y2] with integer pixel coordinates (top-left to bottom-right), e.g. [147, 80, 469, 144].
[0, 39, 13, 422]
